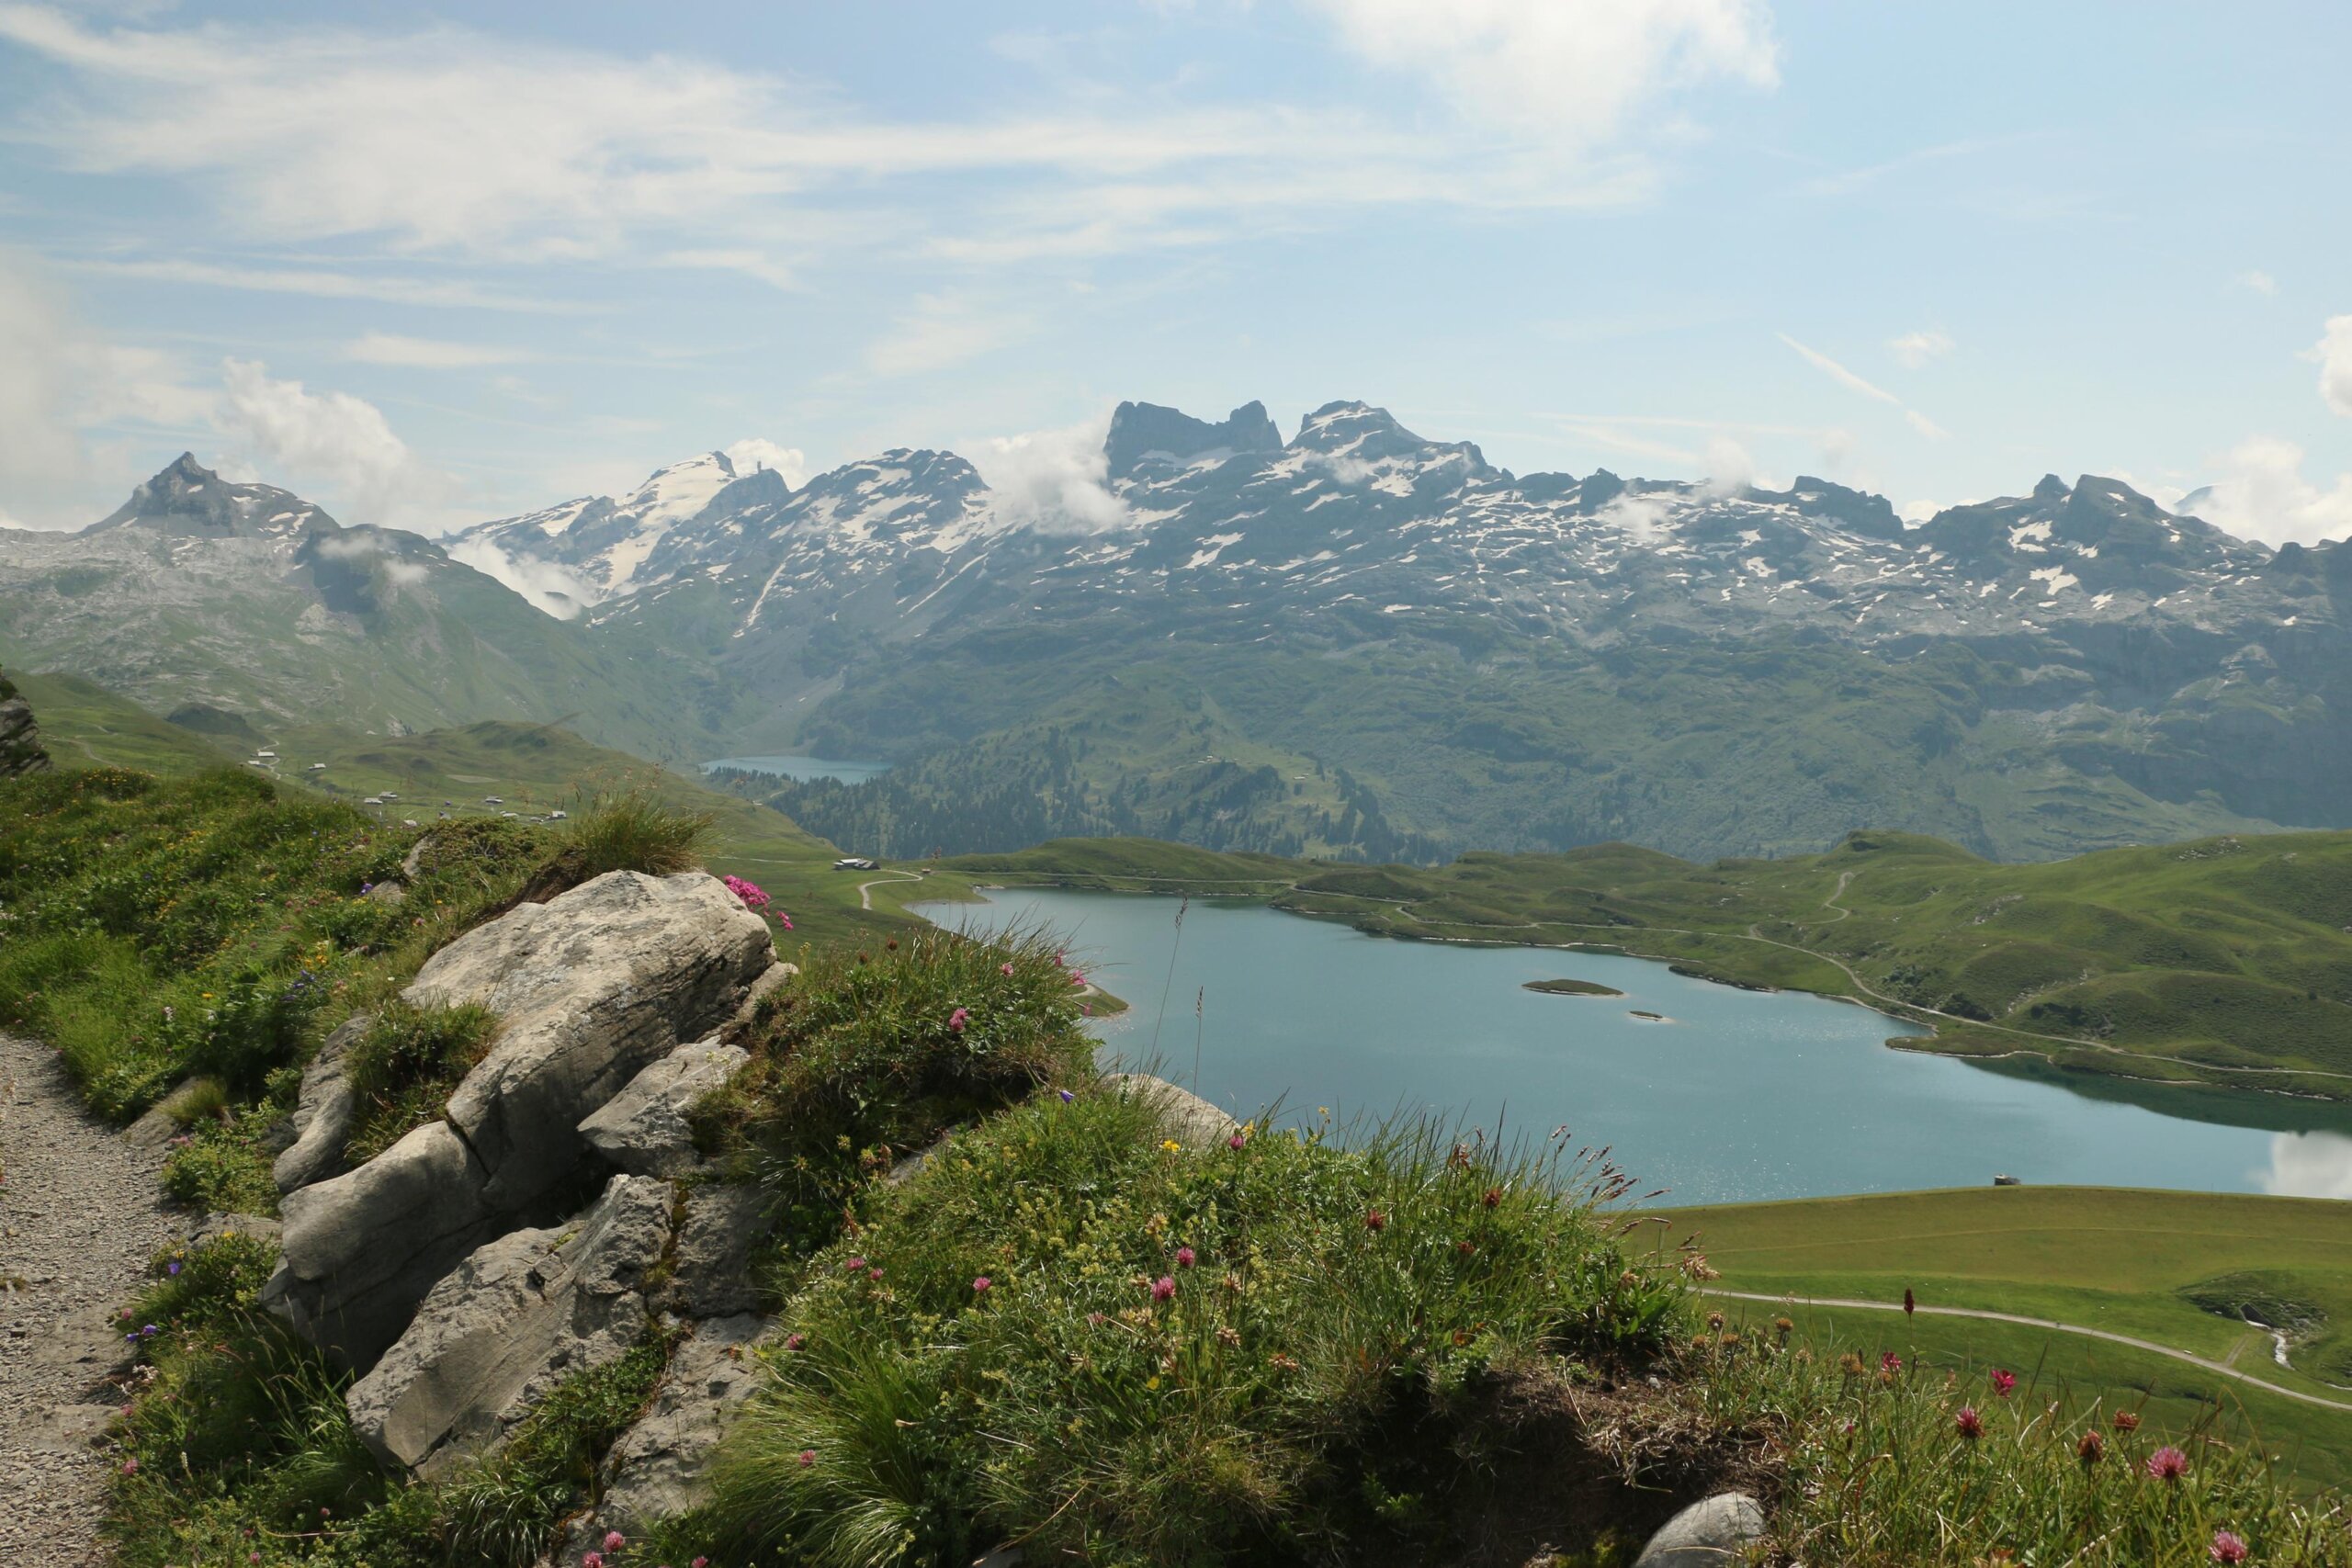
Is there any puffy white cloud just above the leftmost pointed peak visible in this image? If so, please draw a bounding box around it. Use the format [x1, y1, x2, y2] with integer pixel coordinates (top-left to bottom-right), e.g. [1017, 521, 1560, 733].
[214, 360, 454, 522]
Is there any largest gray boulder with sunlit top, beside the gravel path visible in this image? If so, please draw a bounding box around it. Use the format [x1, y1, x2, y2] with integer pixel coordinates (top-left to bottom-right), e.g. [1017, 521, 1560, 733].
[264, 872, 774, 1371]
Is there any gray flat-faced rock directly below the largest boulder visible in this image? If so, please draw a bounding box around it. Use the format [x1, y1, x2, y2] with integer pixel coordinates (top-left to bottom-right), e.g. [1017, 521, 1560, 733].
[344, 1176, 673, 1476]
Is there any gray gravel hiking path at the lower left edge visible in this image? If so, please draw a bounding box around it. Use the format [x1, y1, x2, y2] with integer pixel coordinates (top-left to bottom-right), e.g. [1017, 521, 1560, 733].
[0, 1034, 188, 1568]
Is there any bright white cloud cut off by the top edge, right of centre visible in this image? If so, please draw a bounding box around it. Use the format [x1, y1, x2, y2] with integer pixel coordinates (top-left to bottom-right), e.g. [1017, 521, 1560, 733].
[1307, 0, 1781, 148]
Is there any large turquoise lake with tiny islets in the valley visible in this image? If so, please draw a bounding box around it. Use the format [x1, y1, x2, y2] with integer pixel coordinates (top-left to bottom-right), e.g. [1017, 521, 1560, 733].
[922, 888, 2352, 1203]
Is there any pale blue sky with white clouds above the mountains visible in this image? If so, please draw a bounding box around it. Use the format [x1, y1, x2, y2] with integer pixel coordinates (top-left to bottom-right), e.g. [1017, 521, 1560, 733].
[0, 0, 2352, 543]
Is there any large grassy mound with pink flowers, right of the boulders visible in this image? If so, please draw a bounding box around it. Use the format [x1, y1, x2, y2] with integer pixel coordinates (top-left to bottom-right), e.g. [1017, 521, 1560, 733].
[682, 1093, 1684, 1568]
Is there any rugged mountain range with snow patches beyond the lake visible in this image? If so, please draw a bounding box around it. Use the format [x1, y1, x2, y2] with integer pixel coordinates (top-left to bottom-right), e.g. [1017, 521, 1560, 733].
[0, 402, 2352, 861]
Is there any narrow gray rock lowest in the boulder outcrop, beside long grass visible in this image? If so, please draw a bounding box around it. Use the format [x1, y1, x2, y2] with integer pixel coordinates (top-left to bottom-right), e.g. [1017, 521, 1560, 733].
[574, 1314, 774, 1532]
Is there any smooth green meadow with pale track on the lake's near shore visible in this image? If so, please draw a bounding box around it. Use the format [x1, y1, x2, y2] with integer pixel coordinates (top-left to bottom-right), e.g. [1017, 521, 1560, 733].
[1654, 1187, 2352, 1481]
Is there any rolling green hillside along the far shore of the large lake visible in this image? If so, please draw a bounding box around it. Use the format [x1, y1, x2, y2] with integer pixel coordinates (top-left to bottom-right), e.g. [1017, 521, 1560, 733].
[922, 832, 2352, 1100]
